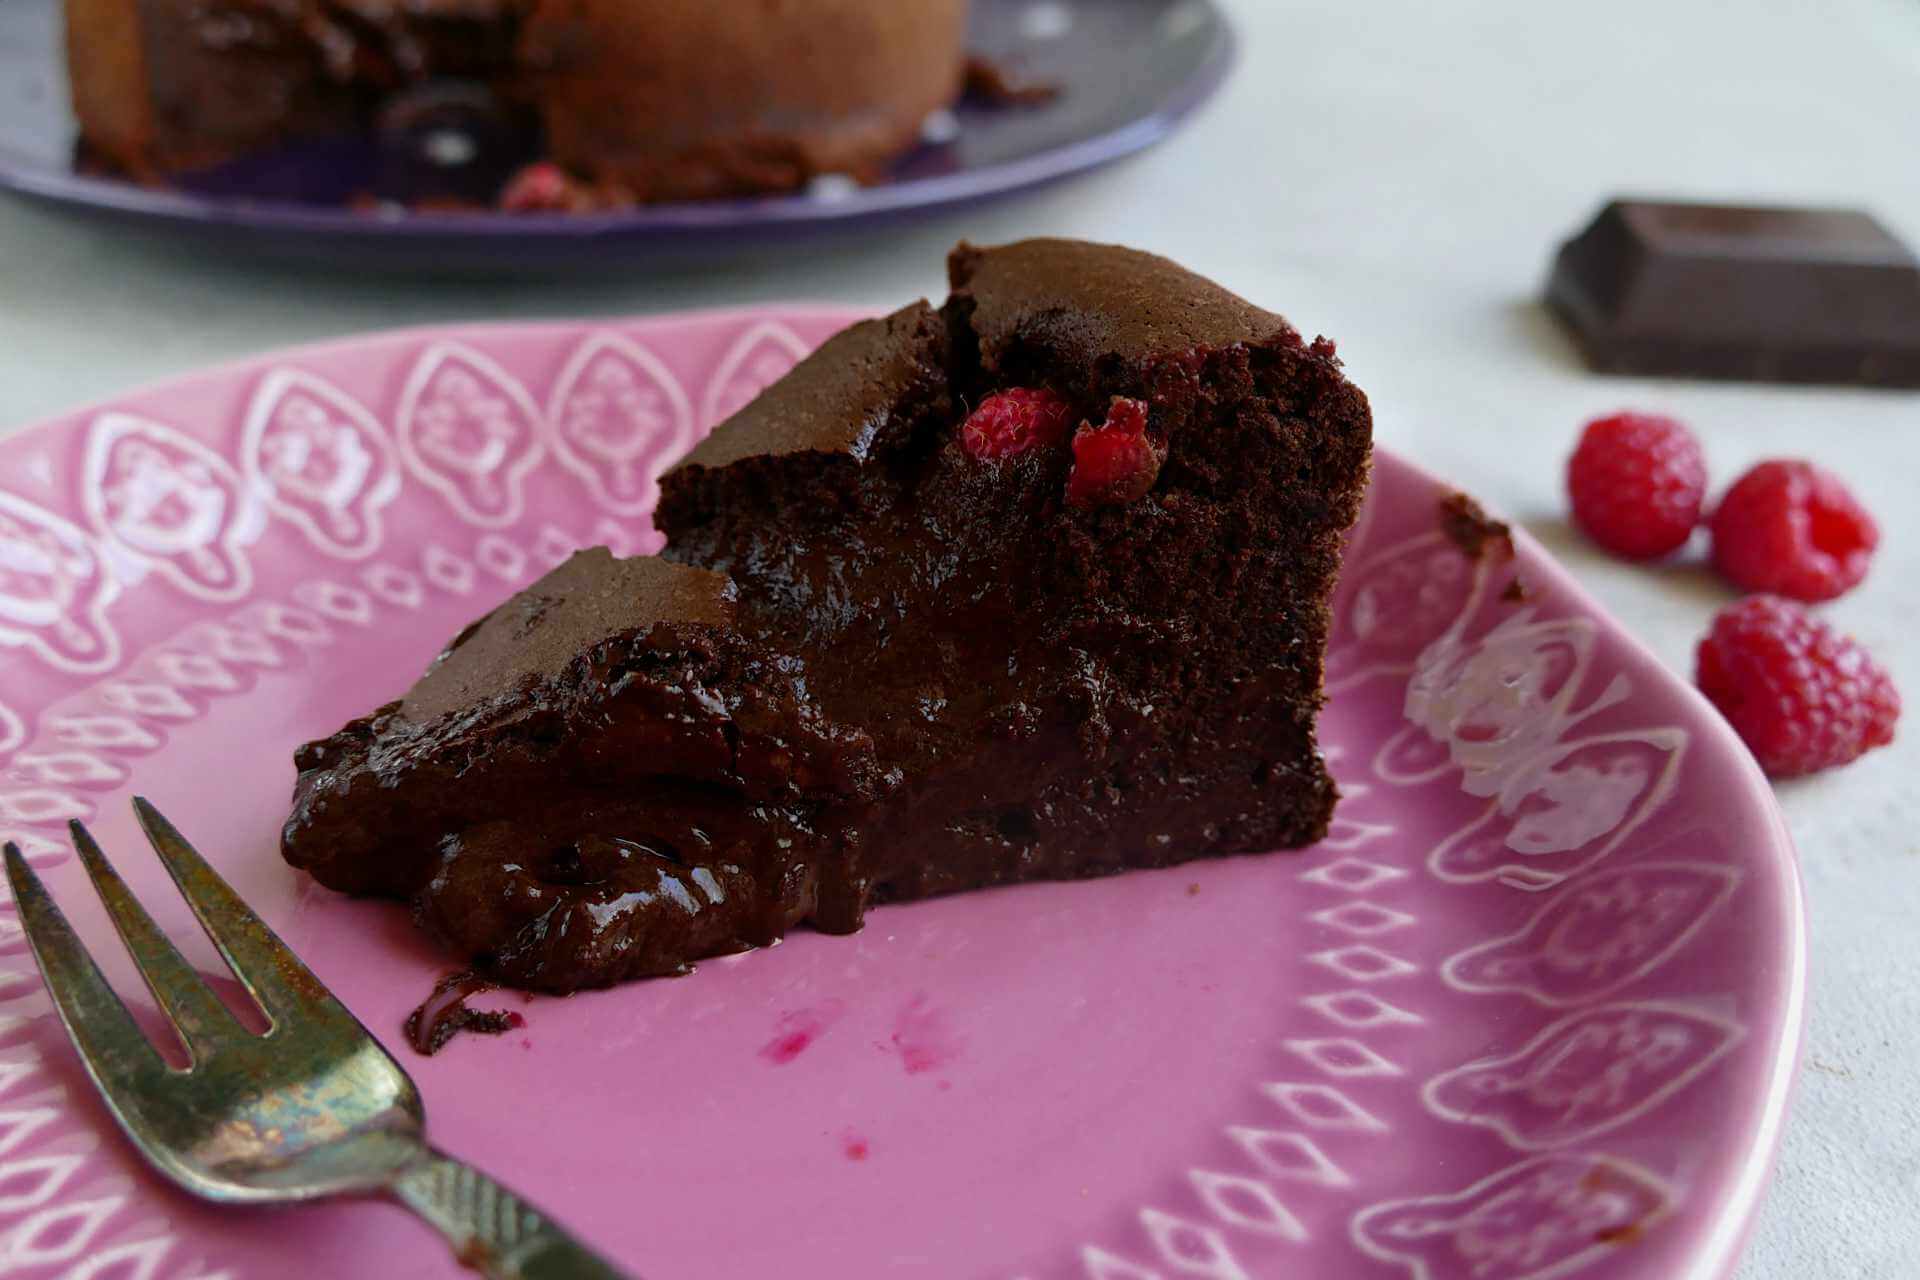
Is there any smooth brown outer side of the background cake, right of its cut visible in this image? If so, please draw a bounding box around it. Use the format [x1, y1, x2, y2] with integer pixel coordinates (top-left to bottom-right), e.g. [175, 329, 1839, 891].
[518, 0, 968, 200]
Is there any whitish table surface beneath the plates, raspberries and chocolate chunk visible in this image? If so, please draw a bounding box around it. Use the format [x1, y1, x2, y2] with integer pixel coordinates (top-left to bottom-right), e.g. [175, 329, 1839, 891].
[0, 0, 1920, 1280]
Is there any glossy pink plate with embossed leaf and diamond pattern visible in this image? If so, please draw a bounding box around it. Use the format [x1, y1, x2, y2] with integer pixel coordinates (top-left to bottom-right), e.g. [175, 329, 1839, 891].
[0, 309, 1805, 1280]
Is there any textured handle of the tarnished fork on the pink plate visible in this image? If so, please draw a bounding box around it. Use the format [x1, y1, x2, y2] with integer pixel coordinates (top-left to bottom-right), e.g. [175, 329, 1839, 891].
[392, 1148, 636, 1280]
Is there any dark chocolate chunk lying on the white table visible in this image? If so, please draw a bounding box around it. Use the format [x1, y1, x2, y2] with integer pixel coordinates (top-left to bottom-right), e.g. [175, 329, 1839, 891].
[1548, 200, 1920, 386]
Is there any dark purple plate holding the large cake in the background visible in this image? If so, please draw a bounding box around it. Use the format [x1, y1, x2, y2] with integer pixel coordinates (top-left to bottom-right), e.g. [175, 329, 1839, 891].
[0, 0, 1233, 273]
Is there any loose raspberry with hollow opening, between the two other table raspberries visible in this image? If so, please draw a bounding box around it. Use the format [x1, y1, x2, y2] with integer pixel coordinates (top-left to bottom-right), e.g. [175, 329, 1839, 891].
[1713, 459, 1880, 601]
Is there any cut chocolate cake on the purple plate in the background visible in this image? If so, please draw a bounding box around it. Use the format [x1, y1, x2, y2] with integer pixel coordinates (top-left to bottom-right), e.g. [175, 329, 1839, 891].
[65, 0, 968, 203]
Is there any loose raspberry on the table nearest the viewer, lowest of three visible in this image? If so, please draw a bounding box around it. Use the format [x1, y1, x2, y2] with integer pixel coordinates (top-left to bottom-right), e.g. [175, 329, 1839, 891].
[1695, 595, 1901, 777]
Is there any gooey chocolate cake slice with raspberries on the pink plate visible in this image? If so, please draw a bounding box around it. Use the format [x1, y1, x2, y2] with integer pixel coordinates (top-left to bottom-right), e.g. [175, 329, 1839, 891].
[282, 240, 1371, 990]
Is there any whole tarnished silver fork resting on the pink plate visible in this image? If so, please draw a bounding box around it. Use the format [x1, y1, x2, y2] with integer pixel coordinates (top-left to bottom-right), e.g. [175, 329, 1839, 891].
[6, 798, 624, 1280]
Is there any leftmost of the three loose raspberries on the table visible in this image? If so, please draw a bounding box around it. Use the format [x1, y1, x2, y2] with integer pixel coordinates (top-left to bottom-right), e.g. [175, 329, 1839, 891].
[1567, 413, 1707, 560]
